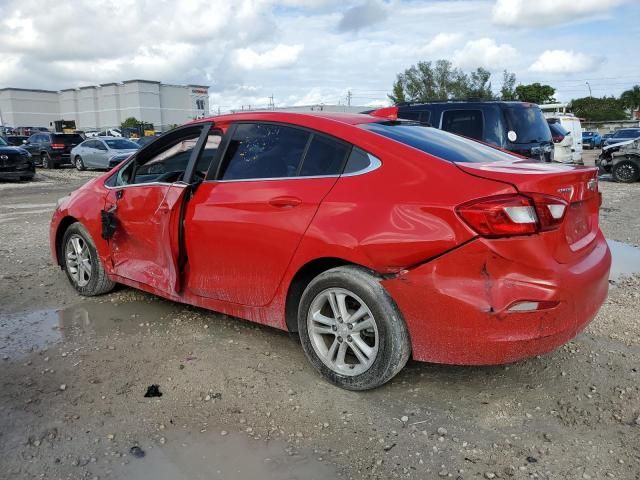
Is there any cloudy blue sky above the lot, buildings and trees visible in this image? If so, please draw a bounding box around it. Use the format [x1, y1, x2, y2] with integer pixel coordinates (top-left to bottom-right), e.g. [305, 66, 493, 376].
[0, 0, 640, 111]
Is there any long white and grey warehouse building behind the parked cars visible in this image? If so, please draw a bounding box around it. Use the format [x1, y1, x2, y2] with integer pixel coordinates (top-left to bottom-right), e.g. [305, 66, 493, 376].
[0, 80, 209, 131]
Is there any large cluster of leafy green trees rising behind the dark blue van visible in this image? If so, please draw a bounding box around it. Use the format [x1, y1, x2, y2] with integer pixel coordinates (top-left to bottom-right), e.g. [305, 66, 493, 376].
[389, 60, 494, 104]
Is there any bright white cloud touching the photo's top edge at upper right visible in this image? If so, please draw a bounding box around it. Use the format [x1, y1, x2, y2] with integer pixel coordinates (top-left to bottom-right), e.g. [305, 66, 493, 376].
[492, 0, 628, 27]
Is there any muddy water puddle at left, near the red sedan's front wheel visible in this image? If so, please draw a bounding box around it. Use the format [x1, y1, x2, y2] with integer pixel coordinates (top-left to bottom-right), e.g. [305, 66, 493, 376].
[0, 302, 174, 358]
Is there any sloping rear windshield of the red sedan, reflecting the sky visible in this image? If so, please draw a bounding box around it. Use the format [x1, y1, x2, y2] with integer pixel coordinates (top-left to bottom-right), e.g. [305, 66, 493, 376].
[359, 122, 516, 163]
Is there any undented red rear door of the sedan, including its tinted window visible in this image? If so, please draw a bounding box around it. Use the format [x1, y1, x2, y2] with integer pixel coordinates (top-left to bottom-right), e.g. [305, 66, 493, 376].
[184, 123, 351, 306]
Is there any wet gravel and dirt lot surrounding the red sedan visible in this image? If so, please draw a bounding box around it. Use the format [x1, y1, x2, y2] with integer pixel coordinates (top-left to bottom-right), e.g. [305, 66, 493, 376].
[0, 155, 640, 480]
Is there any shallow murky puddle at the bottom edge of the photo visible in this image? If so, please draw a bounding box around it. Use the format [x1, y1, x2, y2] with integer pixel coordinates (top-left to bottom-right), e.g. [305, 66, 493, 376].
[113, 431, 342, 480]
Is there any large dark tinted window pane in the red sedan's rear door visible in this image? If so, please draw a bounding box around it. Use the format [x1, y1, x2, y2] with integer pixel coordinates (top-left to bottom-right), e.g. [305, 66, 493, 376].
[220, 123, 310, 180]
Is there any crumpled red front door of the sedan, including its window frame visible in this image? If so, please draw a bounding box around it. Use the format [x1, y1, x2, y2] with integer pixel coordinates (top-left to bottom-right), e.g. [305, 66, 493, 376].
[102, 124, 211, 294]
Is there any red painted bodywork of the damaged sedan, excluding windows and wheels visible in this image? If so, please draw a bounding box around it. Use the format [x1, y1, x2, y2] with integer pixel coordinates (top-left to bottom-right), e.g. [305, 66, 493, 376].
[51, 112, 611, 364]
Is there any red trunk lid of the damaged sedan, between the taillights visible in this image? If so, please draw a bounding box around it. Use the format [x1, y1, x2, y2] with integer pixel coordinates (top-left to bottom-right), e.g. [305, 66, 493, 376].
[456, 160, 601, 263]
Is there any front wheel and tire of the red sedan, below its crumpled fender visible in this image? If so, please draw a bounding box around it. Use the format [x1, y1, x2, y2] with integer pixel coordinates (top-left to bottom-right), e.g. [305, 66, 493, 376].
[60, 222, 115, 297]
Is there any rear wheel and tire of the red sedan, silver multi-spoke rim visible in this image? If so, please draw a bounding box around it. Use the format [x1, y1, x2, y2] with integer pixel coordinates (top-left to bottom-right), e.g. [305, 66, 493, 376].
[298, 266, 411, 390]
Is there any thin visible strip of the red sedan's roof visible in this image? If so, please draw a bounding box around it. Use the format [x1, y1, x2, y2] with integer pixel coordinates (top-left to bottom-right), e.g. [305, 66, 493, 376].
[192, 111, 383, 125]
